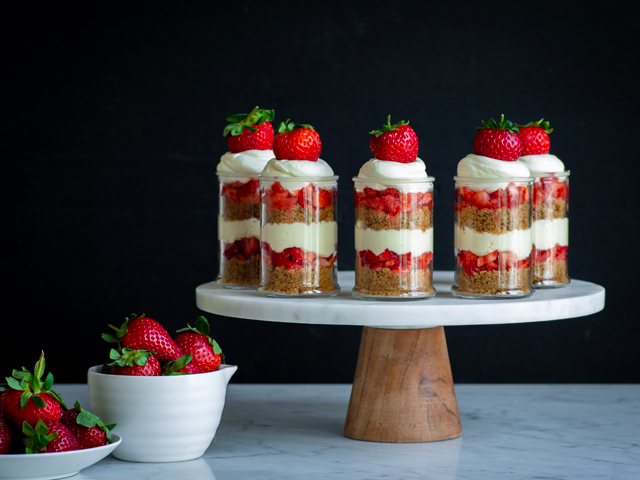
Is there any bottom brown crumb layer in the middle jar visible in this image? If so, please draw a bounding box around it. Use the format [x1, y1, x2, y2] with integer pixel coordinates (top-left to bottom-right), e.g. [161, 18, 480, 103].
[354, 261, 435, 297]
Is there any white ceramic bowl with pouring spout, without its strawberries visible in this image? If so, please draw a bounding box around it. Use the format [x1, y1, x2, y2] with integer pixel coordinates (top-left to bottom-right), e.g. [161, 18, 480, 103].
[88, 365, 238, 462]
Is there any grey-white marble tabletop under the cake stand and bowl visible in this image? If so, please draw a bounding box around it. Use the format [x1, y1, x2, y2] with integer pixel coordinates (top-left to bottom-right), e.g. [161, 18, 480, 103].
[52, 384, 640, 480]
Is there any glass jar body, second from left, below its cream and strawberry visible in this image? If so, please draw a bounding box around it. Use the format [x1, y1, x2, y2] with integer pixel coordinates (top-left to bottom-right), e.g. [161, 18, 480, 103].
[258, 175, 340, 297]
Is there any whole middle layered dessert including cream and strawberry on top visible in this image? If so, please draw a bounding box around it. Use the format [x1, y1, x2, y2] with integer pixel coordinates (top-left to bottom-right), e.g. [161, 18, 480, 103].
[352, 116, 435, 300]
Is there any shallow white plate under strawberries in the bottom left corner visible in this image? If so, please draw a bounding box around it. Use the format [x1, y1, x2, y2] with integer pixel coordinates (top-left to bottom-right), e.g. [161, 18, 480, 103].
[0, 433, 122, 480]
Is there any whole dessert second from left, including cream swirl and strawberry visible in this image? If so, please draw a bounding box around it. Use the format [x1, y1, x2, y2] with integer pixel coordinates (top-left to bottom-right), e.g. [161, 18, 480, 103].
[258, 121, 340, 296]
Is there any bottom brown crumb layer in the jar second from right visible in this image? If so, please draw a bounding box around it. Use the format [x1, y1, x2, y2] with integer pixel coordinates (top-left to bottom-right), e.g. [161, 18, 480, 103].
[454, 268, 533, 297]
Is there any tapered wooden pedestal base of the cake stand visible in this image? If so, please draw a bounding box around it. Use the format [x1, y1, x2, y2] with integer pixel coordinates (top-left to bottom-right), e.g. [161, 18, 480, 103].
[344, 327, 462, 443]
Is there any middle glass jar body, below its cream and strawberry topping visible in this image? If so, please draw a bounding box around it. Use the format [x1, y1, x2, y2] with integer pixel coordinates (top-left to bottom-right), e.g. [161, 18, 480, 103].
[352, 177, 436, 300]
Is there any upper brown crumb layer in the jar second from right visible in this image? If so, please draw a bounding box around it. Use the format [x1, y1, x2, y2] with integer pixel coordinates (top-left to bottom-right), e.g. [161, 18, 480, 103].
[456, 203, 531, 235]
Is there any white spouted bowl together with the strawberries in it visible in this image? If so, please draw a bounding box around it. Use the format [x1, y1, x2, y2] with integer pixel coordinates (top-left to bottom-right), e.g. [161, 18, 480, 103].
[88, 315, 238, 462]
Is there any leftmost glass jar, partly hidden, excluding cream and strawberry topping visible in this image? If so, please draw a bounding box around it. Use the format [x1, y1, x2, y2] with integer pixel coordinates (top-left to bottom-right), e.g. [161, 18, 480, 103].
[216, 172, 260, 289]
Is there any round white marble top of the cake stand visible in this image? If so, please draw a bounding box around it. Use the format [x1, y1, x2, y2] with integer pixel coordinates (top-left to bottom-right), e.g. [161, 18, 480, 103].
[196, 271, 605, 328]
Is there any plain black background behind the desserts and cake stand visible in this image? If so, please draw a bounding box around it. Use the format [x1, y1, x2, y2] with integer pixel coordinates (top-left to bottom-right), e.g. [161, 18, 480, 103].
[0, 1, 640, 383]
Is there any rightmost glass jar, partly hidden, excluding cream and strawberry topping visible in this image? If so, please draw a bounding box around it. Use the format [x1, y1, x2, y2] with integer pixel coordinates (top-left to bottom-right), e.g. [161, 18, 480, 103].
[531, 172, 570, 288]
